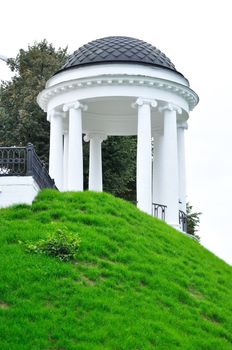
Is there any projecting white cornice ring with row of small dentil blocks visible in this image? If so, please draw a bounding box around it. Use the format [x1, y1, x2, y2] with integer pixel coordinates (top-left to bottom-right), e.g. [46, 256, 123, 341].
[37, 74, 199, 111]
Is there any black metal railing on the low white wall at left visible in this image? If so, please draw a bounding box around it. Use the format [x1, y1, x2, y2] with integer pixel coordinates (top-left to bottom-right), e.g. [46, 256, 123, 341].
[0, 143, 56, 189]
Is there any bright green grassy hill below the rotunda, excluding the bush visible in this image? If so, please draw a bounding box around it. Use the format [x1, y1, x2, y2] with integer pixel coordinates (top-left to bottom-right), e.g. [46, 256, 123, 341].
[0, 190, 232, 350]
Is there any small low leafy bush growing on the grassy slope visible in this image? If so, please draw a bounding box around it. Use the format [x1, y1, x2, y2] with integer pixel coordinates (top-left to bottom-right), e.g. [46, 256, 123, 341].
[24, 229, 80, 261]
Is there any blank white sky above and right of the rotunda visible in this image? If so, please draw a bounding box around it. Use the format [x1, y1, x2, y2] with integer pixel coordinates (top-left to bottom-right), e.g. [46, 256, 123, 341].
[0, 0, 232, 264]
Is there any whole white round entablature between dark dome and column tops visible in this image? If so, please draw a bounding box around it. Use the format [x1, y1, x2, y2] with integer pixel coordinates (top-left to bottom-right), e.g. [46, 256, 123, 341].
[38, 64, 198, 112]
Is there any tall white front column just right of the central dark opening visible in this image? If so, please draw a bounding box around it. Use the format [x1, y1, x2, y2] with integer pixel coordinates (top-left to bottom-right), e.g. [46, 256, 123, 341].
[136, 98, 157, 214]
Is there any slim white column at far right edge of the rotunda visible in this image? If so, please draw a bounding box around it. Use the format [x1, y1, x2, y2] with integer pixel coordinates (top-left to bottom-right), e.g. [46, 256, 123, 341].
[177, 122, 188, 213]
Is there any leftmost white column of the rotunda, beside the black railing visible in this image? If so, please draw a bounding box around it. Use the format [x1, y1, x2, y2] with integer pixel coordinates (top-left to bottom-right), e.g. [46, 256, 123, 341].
[49, 110, 63, 190]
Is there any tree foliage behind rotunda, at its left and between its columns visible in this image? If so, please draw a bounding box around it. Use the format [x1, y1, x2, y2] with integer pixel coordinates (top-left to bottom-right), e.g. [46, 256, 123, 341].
[0, 40, 136, 200]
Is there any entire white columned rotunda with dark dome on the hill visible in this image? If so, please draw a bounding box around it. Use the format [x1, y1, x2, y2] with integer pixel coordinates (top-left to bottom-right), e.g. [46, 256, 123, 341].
[38, 37, 198, 229]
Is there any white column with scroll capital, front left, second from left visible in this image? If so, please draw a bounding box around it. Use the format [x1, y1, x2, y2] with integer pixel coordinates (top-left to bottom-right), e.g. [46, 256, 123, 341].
[63, 101, 87, 191]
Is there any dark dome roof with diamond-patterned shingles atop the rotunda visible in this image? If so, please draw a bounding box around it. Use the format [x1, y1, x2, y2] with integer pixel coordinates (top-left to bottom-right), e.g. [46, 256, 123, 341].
[57, 36, 183, 73]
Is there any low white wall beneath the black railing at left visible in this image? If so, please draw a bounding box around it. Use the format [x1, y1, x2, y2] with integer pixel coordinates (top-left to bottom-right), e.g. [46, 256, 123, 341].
[0, 176, 39, 208]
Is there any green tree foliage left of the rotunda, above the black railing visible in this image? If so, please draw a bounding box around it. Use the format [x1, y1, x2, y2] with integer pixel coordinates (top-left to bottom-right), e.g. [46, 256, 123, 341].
[0, 40, 67, 162]
